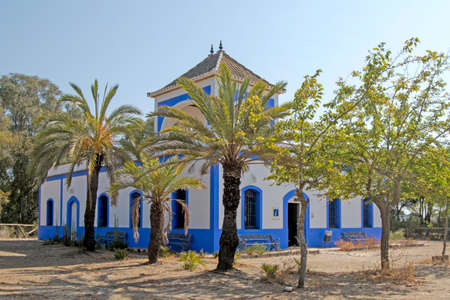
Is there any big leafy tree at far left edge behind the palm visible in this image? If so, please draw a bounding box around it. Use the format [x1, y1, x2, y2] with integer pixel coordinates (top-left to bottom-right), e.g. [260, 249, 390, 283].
[0, 74, 62, 223]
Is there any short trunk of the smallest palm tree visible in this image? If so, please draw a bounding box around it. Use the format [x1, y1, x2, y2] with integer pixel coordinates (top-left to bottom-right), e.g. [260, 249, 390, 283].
[148, 201, 164, 264]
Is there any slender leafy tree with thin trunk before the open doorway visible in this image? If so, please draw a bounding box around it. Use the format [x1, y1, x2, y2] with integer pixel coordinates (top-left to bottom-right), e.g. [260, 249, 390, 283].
[268, 70, 360, 288]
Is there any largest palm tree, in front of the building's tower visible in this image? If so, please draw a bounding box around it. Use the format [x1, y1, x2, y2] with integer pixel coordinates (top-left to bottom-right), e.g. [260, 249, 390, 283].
[149, 64, 289, 271]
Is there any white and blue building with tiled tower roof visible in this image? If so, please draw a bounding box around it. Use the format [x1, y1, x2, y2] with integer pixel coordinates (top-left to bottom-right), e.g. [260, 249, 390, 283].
[38, 45, 381, 252]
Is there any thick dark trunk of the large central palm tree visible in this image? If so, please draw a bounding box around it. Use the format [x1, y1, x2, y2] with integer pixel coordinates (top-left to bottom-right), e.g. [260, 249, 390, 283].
[217, 163, 244, 271]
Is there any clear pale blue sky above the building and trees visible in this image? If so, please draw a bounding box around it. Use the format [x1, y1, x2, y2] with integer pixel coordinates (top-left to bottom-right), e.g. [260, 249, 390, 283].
[0, 0, 450, 113]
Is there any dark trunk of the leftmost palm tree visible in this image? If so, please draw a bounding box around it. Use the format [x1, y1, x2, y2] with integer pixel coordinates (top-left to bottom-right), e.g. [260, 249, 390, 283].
[83, 155, 102, 251]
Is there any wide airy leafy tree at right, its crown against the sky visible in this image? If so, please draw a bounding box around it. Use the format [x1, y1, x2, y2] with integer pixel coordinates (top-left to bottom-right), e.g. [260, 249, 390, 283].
[330, 38, 450, 270]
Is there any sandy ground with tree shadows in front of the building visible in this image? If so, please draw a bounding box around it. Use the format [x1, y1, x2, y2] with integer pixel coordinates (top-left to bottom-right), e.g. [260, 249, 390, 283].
[0, 240, 450, 300]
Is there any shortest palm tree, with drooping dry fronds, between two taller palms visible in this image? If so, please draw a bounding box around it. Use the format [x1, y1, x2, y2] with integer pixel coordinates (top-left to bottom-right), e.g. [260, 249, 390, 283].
[111, 152, 203, 264]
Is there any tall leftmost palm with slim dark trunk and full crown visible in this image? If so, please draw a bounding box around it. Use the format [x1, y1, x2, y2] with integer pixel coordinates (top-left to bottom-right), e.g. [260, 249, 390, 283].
[33, 80, 140, 251]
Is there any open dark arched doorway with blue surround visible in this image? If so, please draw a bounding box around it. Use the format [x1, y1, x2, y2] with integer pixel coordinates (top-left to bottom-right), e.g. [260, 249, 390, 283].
[283, 190, 310, 247]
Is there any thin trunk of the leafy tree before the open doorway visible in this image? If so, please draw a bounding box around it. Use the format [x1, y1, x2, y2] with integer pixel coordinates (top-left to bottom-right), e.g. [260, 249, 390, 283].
[296, 189, 308, 288]
